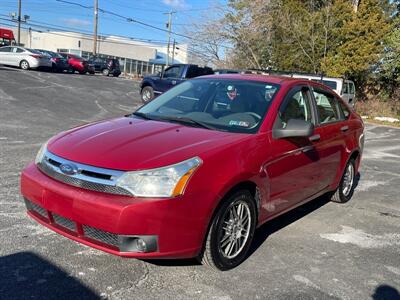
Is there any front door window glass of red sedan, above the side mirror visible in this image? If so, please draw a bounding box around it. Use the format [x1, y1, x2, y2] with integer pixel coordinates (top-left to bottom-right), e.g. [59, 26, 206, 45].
[275, 87, 312, 128]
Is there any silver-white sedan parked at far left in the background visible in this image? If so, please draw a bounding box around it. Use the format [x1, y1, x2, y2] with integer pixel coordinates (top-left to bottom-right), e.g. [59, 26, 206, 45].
[0, 46, 52, 70]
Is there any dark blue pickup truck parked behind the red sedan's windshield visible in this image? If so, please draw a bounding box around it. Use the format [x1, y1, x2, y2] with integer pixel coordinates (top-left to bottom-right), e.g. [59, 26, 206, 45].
[140, 64, 214, 103]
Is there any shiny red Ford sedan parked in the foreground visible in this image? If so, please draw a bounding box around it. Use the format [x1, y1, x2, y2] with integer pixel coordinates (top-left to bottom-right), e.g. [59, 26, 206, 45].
[21, 74, 363, 270]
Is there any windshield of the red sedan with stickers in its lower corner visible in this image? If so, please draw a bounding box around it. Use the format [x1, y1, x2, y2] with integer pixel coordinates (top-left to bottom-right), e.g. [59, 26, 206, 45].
[134, 78, 279, 133]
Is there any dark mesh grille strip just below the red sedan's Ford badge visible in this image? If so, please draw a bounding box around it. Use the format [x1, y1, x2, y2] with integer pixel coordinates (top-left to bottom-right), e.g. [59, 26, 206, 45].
[38, 163, 132, 196]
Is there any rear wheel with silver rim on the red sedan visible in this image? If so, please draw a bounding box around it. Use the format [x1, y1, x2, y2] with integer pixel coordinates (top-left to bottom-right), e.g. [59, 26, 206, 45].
[331, 159, 356, 203]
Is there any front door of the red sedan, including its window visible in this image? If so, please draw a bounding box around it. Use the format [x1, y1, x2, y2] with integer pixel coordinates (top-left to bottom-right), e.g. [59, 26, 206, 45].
[264, 86, 319, 214]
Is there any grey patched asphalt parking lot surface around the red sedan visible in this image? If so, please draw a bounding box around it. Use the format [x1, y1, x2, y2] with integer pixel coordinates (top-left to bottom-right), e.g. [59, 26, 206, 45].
[0, 66, 400, 300]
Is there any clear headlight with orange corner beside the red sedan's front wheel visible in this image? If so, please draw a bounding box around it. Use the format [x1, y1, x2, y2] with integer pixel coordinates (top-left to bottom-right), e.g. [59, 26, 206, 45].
[117, 157, 202, 197]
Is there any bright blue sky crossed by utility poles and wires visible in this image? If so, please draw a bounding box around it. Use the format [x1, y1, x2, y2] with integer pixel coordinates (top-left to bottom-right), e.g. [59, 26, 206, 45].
[0, 0, 227, 43]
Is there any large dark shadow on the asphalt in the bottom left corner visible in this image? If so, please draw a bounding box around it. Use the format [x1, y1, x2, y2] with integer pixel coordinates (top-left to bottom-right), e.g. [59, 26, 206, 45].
[0, 252, 100, 300]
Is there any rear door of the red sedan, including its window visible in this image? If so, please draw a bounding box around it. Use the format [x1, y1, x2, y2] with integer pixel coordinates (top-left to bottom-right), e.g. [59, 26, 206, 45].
[312, 86, 348, 190]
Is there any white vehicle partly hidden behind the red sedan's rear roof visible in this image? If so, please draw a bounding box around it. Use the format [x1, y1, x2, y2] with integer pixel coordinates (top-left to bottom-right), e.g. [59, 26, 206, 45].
[288, 73, 356, 106]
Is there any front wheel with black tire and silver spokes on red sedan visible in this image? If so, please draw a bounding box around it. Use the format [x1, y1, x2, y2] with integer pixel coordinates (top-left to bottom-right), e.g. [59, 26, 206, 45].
[199, 190, 257, 271]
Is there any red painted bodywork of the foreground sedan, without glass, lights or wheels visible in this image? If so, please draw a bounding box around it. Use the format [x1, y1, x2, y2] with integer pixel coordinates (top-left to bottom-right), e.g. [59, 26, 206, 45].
[21, 74, 363, 258]
